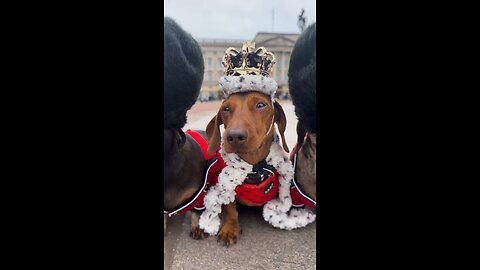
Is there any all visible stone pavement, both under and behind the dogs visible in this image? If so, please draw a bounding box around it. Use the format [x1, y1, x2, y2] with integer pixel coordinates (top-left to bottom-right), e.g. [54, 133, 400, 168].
[164, 100, 316, 270]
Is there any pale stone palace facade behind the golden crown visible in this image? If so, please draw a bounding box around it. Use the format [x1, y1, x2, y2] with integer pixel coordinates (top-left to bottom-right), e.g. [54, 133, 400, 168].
[197, 32, 300, 100]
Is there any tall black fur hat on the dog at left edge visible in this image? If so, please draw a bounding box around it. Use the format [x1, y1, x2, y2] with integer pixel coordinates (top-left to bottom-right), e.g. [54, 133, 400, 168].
[163, 17, 204, 129]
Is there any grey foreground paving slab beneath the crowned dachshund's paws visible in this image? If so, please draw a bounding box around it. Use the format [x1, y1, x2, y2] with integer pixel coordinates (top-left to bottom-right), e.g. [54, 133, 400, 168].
[170, 206, 316, 270]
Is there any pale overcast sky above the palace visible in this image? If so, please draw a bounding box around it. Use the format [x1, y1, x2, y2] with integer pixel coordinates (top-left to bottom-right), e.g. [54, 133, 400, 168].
[164, 0, 317, 39]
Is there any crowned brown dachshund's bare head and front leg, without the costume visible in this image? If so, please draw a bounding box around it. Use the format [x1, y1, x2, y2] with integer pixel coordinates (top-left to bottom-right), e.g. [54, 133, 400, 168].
[206, 92, 289, 245]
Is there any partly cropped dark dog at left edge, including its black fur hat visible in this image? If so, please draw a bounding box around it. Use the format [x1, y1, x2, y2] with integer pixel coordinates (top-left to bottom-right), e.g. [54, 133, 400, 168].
[163, 18, 206, 239]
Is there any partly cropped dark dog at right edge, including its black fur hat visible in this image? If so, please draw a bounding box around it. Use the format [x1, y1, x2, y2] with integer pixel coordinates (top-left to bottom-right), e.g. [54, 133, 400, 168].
[288, 23, 317, 205]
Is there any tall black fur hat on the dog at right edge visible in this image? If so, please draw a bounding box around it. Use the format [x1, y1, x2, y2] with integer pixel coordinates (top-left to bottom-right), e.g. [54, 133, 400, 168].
[288, 23, 317, 133]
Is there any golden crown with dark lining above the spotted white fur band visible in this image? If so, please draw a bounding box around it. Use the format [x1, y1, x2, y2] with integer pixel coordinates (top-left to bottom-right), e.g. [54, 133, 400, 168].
[222, 41, 275, 76]
